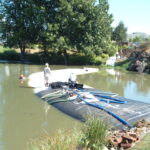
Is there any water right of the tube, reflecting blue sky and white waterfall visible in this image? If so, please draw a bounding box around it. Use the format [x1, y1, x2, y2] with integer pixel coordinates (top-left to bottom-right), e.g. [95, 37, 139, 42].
[78, 69, 150, 103]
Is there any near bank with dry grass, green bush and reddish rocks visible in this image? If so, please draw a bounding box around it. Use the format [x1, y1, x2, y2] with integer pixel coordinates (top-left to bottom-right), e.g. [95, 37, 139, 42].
[28, 117, 150, 150]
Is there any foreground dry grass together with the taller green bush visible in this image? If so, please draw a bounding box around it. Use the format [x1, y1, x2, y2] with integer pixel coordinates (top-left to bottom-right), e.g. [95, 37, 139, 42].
[27, 118, 108, 150]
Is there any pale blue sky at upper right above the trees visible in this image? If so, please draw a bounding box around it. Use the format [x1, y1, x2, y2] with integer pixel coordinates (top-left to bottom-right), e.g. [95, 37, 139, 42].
[108, 0, 150, 35]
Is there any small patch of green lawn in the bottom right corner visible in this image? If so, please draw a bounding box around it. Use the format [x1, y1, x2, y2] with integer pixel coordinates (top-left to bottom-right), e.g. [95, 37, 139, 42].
[129, 133, 150, 150]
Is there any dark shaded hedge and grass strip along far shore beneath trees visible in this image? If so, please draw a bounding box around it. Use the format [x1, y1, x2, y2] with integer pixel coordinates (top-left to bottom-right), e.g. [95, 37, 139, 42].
[0, 46, 108, 65]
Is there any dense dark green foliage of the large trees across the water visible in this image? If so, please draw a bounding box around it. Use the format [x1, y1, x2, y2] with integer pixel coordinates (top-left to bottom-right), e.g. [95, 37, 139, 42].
[0, 0, 114, 64]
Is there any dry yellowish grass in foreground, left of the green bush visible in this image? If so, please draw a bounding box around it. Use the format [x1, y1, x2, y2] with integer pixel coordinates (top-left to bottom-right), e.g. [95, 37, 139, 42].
[27, 130, 78, 150]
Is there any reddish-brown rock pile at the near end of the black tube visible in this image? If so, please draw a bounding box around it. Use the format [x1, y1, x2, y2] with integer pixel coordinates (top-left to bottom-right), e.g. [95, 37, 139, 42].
[104, 120, 150, 150]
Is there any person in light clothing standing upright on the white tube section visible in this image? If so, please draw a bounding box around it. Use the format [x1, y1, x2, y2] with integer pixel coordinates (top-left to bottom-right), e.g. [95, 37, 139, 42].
[44, 63, 51, 87]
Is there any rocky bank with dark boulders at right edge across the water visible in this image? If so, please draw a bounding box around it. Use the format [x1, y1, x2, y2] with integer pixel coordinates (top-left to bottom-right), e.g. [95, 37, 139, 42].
[115, 42, 150, 74]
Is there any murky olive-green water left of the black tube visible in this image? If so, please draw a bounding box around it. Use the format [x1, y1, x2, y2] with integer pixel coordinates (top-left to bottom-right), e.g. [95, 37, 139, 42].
[0, 64, 79, 150]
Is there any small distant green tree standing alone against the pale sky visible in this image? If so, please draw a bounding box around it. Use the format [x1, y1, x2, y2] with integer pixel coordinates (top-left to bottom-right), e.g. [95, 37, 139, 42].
[112, 22, 127, 42]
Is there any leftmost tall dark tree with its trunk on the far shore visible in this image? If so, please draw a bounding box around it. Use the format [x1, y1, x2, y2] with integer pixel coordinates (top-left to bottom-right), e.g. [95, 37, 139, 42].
[2, 0, 43, 62]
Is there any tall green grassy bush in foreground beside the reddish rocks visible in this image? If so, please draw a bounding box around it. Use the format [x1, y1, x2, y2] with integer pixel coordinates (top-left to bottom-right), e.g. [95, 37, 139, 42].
[80, 117, 108, 150]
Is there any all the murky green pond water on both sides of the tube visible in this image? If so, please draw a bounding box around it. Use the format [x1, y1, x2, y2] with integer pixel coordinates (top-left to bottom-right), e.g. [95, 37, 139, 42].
[0, 64, 150, 150]
